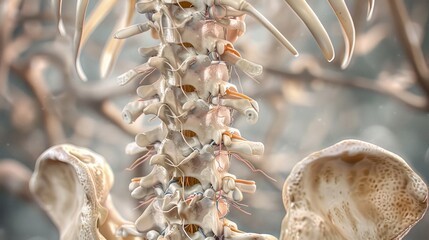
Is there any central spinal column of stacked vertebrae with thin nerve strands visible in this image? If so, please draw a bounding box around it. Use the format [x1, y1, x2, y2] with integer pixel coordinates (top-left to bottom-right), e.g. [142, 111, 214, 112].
[116, 1, 275, 239]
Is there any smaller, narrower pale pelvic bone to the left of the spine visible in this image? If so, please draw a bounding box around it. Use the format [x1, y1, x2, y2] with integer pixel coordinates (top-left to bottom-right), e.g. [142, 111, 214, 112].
[30, 145, 141, 240]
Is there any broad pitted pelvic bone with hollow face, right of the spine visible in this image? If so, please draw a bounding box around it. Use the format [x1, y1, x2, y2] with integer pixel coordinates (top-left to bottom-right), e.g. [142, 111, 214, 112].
[280, 140, 428, 240]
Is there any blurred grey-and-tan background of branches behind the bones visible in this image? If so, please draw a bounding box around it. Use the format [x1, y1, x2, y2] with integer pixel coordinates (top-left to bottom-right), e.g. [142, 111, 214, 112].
[0, 0, 429, 240]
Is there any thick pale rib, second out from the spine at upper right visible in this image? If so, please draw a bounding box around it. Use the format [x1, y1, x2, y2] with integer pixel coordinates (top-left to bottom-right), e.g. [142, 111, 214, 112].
[285, 0, 335, 62]
